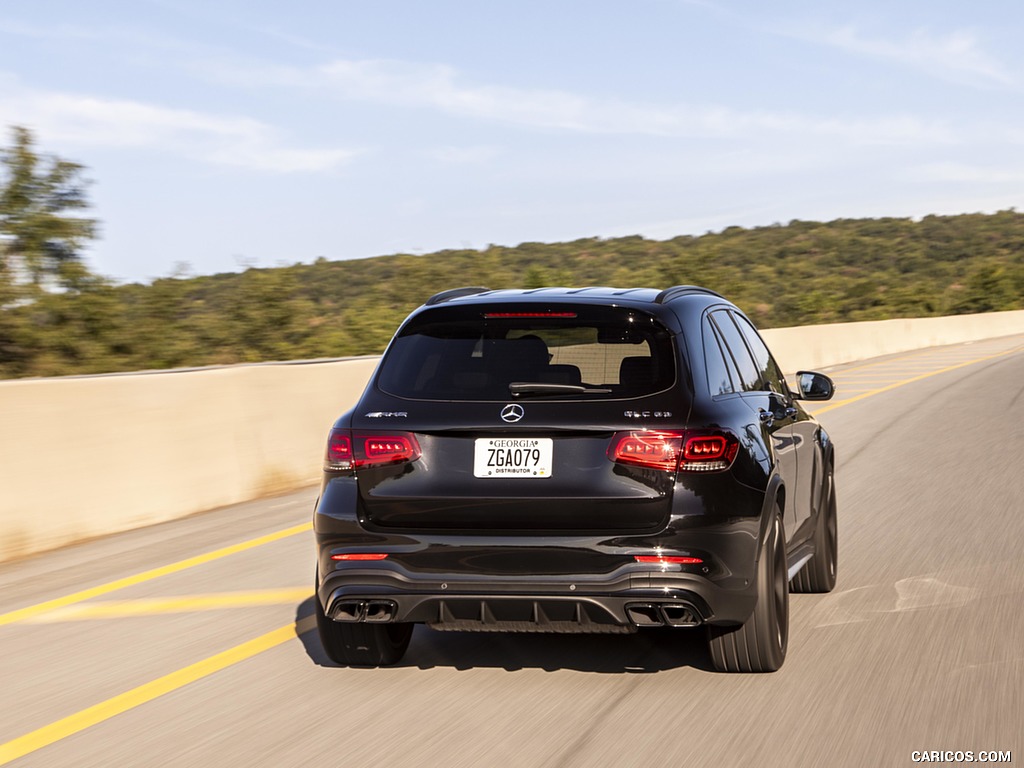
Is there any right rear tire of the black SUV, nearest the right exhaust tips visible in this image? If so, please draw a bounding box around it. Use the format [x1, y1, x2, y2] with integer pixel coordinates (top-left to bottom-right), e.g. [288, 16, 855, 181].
[708, 512, 790, 672]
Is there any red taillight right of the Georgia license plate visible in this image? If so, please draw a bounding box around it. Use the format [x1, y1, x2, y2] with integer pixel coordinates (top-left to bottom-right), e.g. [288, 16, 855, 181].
[608, 429, 739, 472]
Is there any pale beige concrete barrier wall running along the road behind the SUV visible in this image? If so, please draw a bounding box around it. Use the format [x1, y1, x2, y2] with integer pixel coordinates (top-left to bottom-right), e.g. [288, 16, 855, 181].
[0, 311, 1024, 560]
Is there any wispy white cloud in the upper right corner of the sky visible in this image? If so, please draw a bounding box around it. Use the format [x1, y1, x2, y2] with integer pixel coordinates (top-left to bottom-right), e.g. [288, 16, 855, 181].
[785, 26, 1019, 88]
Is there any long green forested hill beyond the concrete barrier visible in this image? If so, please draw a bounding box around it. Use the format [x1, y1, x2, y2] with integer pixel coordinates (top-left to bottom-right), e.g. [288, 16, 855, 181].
[0, 210, 1024, 377]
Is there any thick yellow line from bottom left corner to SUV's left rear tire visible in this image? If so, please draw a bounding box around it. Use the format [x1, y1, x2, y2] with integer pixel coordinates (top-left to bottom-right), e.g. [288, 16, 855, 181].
[0, 616, 315, 765]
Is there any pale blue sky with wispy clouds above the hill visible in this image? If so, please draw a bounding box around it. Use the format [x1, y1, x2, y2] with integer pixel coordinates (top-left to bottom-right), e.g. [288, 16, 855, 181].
[0, 0, 1024, 282]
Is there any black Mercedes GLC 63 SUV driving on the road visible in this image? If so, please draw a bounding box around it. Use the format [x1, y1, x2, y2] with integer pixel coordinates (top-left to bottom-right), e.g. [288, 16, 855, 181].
[314, 286, 837, 672]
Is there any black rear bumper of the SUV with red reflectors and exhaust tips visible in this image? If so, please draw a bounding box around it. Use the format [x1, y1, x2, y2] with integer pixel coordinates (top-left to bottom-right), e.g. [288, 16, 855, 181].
[313, 478, 760, 632]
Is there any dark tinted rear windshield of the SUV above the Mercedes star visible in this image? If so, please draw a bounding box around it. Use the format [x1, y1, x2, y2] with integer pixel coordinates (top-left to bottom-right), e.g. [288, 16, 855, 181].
[377, 304, 676, 401]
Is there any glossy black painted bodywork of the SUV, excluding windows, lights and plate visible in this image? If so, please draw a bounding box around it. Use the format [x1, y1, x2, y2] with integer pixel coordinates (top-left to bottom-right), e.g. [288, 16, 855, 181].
[313, 289, 831, 631]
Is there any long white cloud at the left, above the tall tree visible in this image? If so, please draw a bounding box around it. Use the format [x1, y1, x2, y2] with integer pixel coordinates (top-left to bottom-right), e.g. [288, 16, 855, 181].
[0, 76, 356, 172]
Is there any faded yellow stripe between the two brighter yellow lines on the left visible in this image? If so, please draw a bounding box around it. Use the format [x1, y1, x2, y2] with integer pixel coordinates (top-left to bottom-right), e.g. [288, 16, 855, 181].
[23, 587, 312, 624]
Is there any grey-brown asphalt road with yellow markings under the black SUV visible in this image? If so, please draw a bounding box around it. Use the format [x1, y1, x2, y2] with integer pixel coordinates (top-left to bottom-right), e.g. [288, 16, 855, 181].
[0, 336, 1024, 768]
